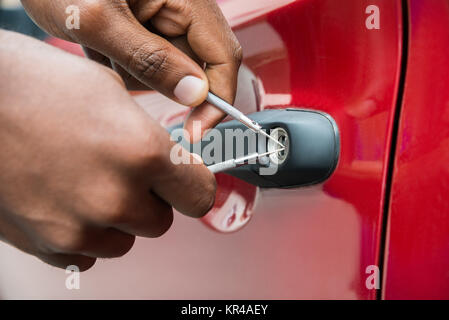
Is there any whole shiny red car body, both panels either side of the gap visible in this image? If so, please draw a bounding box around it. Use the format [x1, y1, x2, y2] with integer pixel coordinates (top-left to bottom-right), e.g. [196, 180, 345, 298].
[0, 0, 449, 299]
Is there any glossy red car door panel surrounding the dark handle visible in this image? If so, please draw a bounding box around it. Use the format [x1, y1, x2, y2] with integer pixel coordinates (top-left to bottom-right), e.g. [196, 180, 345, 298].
[0, 0, 404, 299]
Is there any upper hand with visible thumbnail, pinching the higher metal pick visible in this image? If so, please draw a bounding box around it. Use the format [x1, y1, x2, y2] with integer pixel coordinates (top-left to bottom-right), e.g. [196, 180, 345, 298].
[22, 0, 242, 140]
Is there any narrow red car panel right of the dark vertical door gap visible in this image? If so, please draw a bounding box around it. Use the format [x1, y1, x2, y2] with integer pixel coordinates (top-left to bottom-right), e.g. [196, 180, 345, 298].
[383, 0, 449, 299]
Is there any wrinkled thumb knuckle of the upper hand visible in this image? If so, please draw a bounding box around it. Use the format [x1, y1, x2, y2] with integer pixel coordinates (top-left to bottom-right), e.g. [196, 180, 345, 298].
[128, 45, 168, 81]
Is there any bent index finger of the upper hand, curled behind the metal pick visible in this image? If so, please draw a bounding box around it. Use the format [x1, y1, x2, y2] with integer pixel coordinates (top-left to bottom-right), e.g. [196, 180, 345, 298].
[132, 0, 242, 137]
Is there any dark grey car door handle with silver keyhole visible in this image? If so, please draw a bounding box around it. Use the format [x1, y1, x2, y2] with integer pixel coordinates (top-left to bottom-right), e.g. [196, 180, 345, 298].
[169, 108, 340, 188]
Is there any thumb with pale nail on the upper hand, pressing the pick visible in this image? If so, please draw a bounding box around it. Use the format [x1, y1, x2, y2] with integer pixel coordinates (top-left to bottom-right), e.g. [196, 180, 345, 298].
[88, 16, 209, 107]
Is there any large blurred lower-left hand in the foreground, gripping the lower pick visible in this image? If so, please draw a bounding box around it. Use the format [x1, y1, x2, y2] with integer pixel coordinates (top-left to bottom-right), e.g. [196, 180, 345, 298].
[0, 31, 215, 270]
